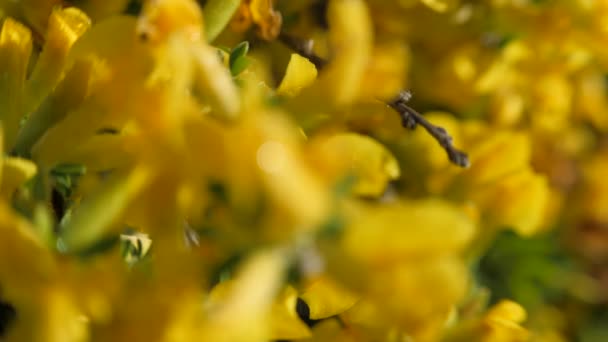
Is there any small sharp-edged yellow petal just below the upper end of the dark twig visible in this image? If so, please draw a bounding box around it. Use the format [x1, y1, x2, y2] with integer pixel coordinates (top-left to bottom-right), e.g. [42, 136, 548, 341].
[277, 53, 317, 96]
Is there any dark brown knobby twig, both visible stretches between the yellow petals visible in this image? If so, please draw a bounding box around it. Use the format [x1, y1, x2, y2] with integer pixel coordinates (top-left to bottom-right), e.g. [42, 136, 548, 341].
[279, 33, 469, 167]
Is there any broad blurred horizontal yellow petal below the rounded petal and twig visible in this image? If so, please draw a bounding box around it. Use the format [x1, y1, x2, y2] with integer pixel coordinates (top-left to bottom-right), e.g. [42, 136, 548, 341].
[343, 200, 475, 265]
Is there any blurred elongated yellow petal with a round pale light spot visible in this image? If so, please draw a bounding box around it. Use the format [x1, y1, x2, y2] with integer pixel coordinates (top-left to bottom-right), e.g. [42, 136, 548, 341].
[245, 112, 330, 229]
